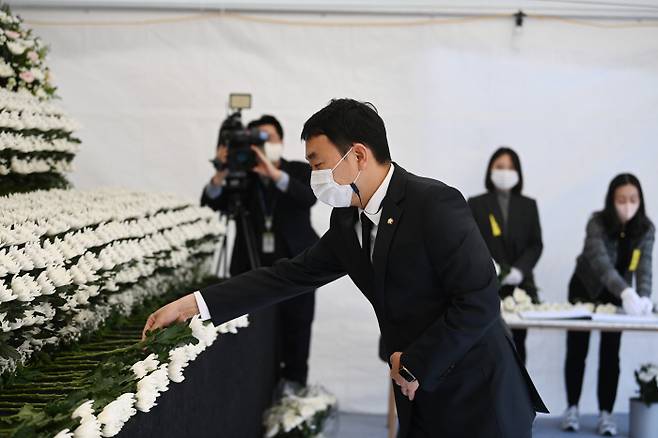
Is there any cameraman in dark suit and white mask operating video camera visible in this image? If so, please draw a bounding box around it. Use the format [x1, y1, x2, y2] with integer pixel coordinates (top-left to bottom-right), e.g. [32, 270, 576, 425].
[201, 115, 318, 391]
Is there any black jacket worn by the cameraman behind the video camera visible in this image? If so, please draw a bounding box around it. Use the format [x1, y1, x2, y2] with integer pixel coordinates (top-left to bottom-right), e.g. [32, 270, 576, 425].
[201, 159, 319, 275]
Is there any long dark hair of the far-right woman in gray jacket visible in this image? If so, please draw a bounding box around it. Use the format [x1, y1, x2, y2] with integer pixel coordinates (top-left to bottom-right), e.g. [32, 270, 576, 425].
[596, 173, 653, 238]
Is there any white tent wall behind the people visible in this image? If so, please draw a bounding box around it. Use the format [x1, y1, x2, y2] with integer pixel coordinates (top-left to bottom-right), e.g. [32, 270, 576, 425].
[12, 9, 658, 413]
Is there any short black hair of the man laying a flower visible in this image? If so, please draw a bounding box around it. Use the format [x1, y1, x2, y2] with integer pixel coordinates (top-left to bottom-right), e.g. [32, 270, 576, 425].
[301, 99, 391, 163]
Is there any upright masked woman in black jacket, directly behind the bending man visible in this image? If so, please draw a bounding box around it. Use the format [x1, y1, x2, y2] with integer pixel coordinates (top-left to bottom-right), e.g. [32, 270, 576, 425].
[468, 147, 543, 363]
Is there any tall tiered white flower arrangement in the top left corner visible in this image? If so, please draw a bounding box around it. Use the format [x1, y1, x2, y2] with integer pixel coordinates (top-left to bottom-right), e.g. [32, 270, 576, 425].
[0, 6, 80, 195]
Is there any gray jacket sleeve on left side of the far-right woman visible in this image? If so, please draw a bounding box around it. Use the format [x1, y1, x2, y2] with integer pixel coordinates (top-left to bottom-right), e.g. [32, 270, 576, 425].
[583, 218, 630, 297]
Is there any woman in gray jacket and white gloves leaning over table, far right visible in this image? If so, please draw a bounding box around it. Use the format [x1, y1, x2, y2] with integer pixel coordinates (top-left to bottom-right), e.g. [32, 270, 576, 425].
[562, 173, 655, 436]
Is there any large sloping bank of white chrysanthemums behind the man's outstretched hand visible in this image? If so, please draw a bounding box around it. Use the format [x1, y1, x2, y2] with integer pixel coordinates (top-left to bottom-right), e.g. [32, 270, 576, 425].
[0, 190, 224, 374]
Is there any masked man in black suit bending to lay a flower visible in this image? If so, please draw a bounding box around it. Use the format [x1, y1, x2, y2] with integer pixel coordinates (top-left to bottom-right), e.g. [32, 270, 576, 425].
[144, 99, 546, 438]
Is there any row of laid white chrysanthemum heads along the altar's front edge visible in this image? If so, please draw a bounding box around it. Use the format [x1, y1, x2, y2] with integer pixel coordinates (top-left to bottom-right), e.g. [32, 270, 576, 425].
[50, 315, 249, 438]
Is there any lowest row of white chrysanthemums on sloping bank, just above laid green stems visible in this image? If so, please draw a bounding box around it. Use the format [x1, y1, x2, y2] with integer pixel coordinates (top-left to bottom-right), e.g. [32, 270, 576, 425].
[0, 254, 212, 375]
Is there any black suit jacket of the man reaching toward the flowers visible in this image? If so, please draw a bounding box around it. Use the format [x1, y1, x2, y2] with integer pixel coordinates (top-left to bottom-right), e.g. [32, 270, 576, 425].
[201, 166, 546, 438]
